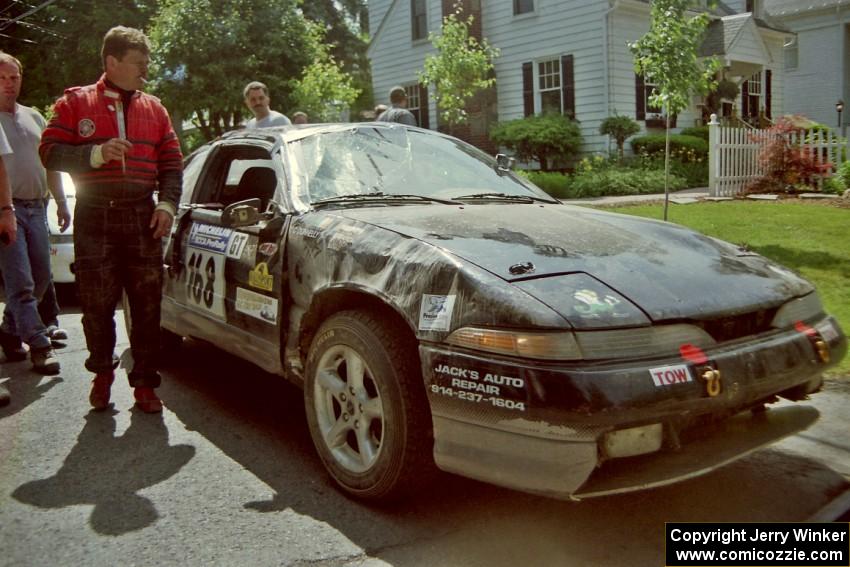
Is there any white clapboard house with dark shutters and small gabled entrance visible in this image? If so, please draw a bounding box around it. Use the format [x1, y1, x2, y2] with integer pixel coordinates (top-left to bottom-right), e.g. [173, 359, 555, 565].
[368, 0, 792, 152]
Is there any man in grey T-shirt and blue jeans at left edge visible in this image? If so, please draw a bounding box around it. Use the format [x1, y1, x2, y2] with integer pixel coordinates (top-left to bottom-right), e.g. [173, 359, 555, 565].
[0, 52, 71, 374]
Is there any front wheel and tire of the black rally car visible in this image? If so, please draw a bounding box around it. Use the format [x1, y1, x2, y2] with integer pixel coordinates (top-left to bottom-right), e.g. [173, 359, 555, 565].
[304, 311, 433, 500]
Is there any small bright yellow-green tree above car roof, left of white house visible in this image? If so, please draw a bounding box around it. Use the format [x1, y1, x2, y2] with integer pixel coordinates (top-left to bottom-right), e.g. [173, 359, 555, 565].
[292, 56, 360, 122]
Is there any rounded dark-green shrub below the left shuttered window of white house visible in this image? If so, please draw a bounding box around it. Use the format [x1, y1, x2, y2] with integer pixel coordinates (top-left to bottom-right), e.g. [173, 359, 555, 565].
[490, 114, 582, 171]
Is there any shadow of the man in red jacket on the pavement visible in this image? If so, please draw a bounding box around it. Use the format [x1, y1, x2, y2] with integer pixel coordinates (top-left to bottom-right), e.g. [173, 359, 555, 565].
[12, 408, 195, 535]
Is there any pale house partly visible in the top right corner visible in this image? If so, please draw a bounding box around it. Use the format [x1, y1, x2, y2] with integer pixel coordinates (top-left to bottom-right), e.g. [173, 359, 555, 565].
[765, 0, 850, 133]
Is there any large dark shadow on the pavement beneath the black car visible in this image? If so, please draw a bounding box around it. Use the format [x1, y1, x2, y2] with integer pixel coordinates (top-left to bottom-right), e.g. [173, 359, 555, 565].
[152, 341, 847, 567]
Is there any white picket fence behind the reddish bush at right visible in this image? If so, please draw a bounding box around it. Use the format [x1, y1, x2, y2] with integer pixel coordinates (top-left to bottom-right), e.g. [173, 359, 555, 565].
[708, 114, 848, 197]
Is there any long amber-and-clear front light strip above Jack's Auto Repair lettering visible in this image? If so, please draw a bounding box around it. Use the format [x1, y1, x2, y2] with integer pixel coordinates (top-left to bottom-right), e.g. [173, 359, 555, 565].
[446, 325, 716, 360]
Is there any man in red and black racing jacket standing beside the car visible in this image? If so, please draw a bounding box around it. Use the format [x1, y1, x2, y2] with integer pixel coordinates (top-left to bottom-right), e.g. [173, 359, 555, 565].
[39, 26, 183, 413]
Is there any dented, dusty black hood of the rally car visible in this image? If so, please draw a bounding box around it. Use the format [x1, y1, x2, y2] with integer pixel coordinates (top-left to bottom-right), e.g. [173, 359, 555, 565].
[335, 203, 813, 322]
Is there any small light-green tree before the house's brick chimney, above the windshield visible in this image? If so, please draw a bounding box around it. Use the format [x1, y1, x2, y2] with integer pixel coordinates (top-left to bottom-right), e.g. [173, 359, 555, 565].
[419, 3, 499, 129]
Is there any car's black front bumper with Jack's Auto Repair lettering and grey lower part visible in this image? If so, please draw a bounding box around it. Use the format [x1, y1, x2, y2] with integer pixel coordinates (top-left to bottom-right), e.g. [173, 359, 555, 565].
[420, 317, 847, 498]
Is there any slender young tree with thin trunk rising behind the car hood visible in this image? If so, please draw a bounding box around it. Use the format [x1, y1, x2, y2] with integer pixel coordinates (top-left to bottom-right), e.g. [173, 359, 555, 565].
[629, 0, 720, 220]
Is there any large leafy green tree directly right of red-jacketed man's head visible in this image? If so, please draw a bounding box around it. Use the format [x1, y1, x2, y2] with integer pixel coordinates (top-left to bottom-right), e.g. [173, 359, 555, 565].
[150, 0, 325, 140]
